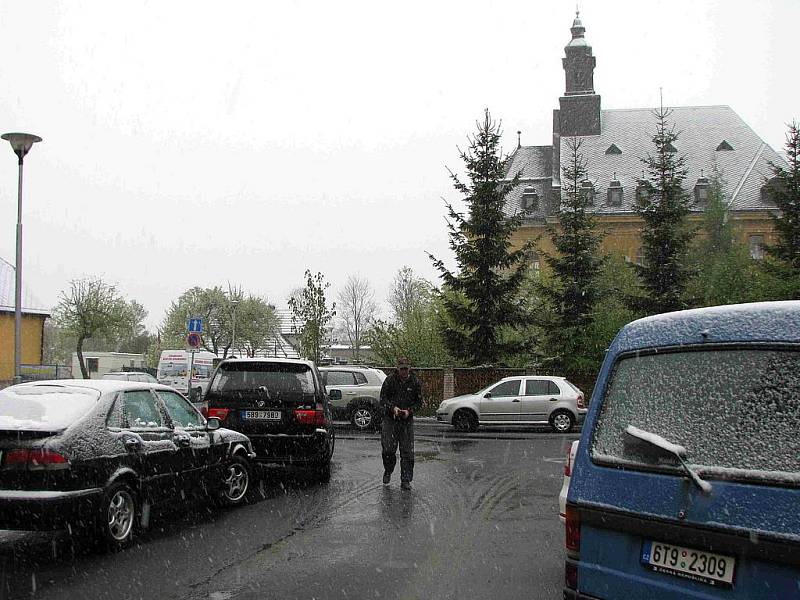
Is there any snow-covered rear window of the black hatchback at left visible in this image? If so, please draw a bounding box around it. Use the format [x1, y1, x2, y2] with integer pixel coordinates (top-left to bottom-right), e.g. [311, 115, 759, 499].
[0, 385, 100, 431]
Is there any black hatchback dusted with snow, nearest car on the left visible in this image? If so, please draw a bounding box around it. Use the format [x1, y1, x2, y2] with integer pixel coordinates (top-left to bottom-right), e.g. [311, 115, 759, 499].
[0, 380, 253, 548]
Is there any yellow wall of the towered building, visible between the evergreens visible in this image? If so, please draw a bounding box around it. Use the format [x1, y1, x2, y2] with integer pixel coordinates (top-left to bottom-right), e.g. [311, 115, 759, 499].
[511, 211, 776, 267]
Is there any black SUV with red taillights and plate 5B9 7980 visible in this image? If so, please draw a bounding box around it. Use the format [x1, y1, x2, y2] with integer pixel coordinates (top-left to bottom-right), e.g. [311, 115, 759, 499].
[206, 358, 335, 479]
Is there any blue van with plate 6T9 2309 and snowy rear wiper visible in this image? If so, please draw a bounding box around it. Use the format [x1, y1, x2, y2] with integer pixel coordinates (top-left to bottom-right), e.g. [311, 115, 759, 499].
[564, 301, 800, 600]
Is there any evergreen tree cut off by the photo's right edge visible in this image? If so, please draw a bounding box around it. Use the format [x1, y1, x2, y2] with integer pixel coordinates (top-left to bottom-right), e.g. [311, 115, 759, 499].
[765, 123, 800, 298]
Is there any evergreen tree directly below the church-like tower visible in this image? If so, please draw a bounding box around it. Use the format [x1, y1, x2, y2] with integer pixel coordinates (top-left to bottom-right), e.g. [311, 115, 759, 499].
[539, 138, 604, 375]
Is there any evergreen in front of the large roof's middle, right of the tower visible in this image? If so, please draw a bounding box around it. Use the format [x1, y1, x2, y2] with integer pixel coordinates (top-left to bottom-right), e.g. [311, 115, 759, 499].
[631, 107, 692, 314]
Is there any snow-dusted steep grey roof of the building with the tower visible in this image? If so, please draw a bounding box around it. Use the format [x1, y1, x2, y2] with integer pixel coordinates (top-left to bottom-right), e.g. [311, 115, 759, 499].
[506, 106, 785, 216]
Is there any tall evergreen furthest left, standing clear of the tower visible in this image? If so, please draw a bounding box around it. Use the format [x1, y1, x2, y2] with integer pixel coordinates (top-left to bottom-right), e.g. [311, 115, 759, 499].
[429, 110, 529, 365]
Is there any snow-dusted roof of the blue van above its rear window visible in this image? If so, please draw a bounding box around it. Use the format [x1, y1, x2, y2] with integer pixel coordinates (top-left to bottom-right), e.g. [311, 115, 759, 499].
[609, 300, 800, 354]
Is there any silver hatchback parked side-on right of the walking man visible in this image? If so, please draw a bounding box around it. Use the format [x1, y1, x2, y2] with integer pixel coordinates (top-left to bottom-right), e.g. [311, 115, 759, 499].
[436, 375, 586, 433]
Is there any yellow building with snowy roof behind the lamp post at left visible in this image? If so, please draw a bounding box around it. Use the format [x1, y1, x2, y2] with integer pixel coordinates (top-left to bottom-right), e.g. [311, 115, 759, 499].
[0, 258, 50, 386]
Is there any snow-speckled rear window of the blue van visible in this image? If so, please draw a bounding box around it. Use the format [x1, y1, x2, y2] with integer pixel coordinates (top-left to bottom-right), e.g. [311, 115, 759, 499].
[591, 348, 800, 485]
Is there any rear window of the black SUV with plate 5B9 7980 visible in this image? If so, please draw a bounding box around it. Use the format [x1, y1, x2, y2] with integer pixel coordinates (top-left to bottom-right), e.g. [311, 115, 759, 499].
[211, 362, 314, 397]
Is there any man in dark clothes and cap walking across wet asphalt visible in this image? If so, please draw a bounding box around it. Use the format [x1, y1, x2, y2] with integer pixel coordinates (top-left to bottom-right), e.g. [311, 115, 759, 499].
[381, 358, 422, 490]
